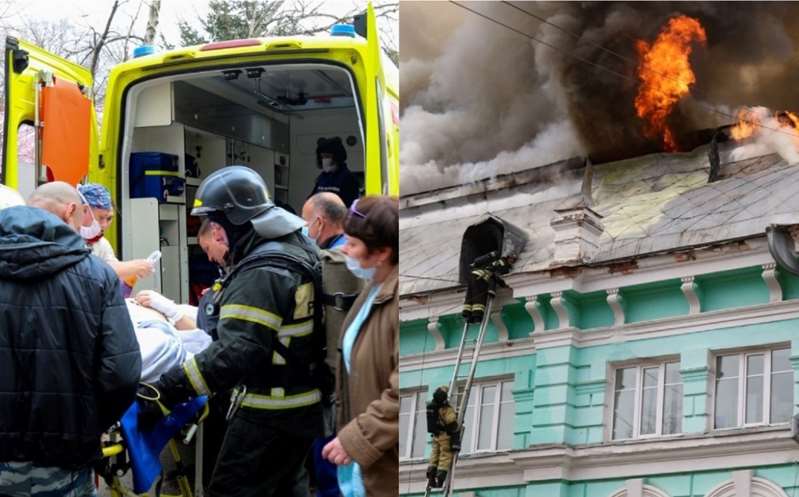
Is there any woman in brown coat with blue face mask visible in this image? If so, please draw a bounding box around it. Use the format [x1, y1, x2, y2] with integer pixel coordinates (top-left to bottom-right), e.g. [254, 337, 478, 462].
[322, 197, 399, 497]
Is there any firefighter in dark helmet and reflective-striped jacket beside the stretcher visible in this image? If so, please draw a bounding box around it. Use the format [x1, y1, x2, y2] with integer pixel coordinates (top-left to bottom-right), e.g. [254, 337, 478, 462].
[145, 166, 329, 497]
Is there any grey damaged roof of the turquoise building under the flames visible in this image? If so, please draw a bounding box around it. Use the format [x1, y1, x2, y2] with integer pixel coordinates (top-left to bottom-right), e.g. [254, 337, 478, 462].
[400, 144, 799, 295]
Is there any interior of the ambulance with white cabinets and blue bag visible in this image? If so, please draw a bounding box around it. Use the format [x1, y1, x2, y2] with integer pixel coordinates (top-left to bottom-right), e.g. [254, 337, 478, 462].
[119, 63, 364, 305]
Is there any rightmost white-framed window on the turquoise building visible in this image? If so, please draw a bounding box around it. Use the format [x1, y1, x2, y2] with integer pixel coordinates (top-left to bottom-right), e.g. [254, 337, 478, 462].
[713, 348, 793, 429]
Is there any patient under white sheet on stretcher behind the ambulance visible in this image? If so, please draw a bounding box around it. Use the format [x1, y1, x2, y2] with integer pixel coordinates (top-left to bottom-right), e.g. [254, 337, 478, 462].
[125, 290, 211, 383]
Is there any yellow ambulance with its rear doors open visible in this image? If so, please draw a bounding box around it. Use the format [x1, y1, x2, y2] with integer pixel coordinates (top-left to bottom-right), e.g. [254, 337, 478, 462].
[0, 4, 399, 302]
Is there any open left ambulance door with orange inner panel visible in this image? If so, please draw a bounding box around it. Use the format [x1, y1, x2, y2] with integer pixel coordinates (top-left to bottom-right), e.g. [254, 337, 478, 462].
[0, 37, 97, 197]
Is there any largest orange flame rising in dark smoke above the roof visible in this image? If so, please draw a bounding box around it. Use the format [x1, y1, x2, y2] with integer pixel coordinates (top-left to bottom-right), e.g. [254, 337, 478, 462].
[635, 16, 707, 152]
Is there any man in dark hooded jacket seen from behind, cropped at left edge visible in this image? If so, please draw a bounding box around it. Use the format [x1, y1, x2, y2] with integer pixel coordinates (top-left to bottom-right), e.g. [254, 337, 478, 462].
[0, 182, 141, 496]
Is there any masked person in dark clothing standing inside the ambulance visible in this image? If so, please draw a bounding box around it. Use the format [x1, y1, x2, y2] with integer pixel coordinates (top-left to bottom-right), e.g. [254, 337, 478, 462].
[311, 136, 360, 207]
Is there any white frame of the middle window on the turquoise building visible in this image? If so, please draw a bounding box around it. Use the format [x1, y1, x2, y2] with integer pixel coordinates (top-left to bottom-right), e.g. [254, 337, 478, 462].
[608, 358, 685, 442]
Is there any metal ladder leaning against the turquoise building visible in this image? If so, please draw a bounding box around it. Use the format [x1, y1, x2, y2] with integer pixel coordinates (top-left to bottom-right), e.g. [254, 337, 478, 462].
[424, 278, 496, 497]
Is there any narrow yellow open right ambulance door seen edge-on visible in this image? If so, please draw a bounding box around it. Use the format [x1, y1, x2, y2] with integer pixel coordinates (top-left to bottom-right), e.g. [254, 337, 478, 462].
[355, 2, 399, 195]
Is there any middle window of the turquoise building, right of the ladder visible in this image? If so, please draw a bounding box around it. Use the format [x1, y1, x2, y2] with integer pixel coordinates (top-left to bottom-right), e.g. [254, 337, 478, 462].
[612, 361, 682, 440]
